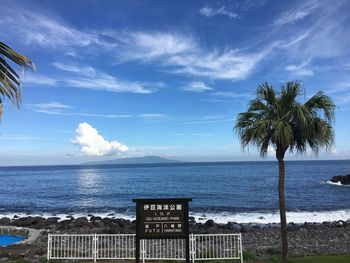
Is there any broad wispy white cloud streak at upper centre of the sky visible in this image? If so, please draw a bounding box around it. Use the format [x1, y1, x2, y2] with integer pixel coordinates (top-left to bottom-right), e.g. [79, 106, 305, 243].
[111, 32, 275, 80]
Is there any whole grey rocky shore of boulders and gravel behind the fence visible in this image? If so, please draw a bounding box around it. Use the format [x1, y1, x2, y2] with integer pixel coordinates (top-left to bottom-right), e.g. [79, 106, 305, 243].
[0, 215, 350, 262]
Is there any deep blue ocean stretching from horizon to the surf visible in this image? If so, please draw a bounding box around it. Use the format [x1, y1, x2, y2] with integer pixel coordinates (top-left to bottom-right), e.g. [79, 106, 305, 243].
[0, 160, 350, 223]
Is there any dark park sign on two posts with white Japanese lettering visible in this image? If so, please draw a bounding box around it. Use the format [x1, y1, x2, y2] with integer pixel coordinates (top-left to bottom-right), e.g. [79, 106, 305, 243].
[133, 198, 192, 263]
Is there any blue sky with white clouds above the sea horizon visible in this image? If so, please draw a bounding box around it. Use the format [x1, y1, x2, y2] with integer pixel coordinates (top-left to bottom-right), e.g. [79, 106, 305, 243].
[0, 0, 350, 165]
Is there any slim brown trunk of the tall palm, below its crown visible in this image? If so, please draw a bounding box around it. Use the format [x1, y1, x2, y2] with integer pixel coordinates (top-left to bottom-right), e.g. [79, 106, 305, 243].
[278, 158, 288, 263]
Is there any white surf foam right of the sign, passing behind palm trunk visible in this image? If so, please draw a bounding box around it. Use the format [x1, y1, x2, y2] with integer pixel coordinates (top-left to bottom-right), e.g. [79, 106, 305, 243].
[192, 209, 350, 224]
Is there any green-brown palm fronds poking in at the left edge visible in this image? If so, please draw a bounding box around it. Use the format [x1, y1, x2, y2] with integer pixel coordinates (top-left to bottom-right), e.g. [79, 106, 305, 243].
[0, 42, 35, 117]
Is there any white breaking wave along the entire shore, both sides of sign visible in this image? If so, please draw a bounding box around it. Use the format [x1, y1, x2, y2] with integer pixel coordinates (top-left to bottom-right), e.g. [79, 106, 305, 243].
[0, 209, 350, 224]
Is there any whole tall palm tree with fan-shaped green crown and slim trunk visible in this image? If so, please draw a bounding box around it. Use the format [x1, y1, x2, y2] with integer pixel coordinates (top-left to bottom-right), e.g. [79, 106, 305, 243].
[235, 81, 335, 262]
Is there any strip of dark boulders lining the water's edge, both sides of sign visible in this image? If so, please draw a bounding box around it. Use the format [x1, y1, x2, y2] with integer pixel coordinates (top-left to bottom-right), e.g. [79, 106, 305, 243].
[0, 215, 350, 233]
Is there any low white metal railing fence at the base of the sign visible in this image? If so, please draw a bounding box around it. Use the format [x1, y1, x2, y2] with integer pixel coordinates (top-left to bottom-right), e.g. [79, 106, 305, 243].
[47, 234, 243, 262]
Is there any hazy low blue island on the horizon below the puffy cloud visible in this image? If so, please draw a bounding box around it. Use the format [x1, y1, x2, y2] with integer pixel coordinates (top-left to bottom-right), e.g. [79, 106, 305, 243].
[84, 155, 183, 165]
